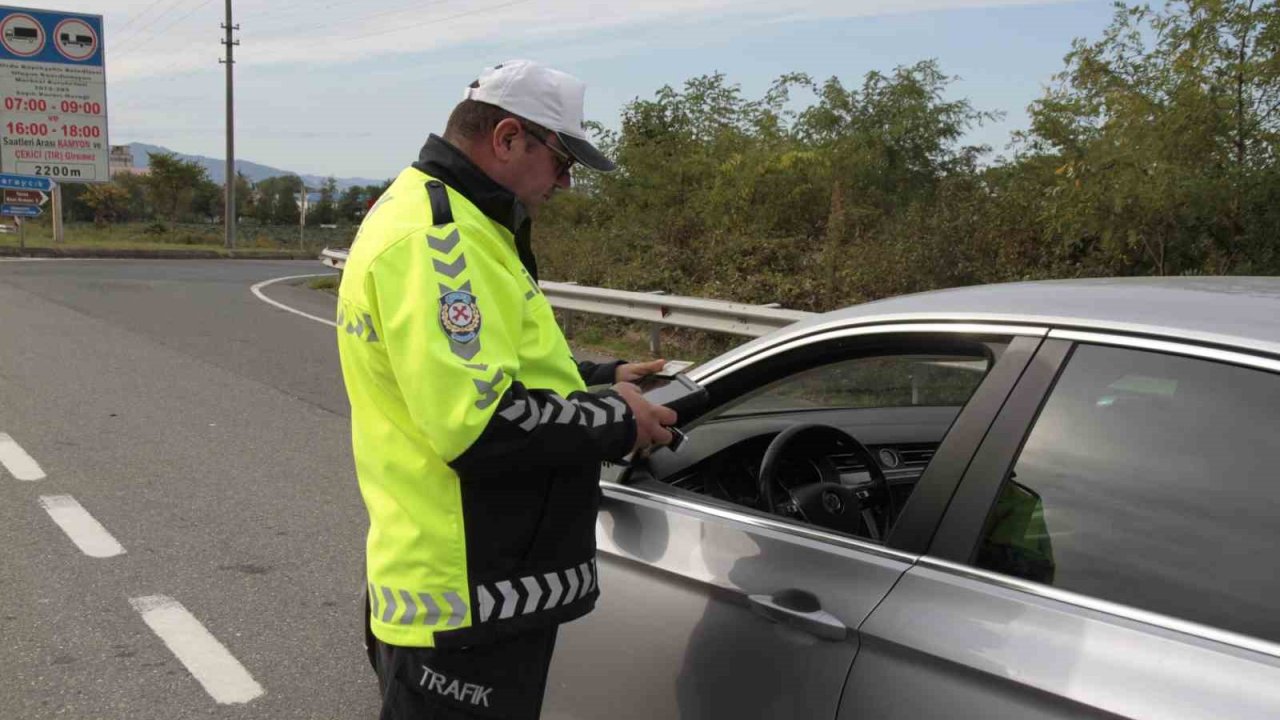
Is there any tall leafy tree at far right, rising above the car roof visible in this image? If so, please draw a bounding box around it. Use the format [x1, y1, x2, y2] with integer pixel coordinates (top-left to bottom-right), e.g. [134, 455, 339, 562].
[1025, 0, 1280, 274]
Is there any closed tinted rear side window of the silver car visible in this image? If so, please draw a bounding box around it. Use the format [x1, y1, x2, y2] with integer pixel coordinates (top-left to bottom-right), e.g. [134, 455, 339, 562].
[977, 346, 1280, 641]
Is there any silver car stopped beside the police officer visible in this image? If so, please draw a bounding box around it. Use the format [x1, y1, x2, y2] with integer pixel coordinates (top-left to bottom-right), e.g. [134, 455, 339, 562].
[544, 278, 1280, 720]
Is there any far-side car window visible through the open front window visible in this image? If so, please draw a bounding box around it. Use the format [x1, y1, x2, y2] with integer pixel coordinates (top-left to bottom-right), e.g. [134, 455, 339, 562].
[719, 355, 991, 416]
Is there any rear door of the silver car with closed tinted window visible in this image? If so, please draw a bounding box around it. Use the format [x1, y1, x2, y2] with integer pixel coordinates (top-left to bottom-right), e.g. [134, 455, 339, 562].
[840, 331, 1280, 720]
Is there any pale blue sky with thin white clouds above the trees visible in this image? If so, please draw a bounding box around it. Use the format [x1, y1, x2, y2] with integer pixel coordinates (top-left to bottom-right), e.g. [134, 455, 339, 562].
[14, 0, 1112, 178]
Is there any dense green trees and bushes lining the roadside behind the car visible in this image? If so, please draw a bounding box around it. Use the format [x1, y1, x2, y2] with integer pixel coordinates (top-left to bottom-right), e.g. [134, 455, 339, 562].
[536, 0, 1280, 310]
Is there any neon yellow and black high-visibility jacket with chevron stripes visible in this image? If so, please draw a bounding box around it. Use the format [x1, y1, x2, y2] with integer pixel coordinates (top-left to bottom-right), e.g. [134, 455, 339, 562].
[338, 136, 635, 647]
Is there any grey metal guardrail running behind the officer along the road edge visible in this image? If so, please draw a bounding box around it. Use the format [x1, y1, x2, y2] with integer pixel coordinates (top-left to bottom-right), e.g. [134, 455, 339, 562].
[320, 247, 813, 355]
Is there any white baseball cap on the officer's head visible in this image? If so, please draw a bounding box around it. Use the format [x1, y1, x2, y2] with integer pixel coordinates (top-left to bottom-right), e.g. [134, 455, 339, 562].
[462, 60, 617, 173]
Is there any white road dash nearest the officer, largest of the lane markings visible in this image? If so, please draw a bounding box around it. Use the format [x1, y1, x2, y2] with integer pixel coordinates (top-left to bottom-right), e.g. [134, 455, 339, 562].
[129, 594, 266, 705]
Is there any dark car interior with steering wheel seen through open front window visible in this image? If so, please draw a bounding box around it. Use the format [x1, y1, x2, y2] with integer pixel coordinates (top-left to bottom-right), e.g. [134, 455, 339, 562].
[620, 336, 1007, 542]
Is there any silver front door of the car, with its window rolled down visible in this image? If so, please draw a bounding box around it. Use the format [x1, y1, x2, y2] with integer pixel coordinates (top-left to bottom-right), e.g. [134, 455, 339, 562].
[544, 328, 1039, 720]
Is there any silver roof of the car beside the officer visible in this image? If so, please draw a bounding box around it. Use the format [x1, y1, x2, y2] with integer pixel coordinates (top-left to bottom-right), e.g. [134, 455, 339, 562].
[714, 277, 1280, 376]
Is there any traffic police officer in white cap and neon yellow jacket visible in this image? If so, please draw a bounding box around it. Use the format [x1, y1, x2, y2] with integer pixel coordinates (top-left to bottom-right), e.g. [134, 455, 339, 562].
[338, 60, 676, 719]
